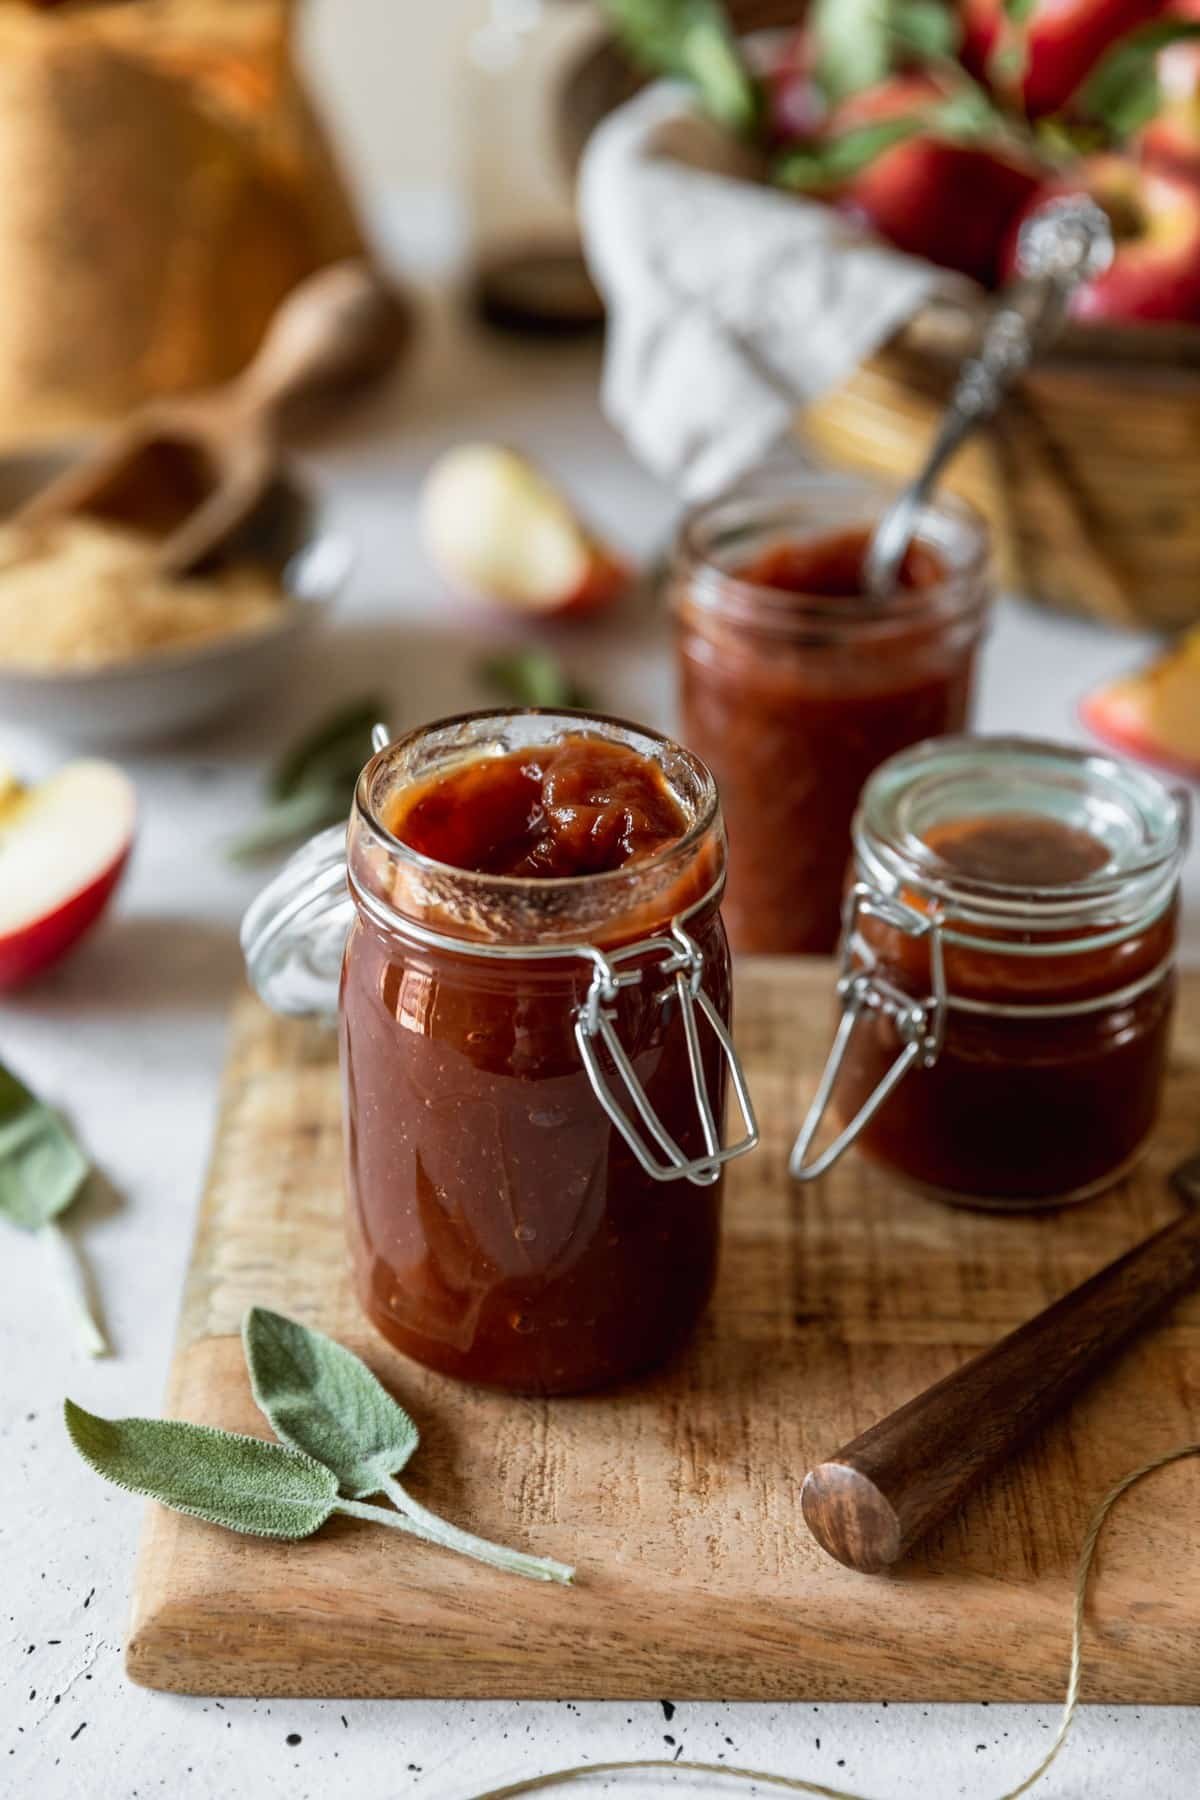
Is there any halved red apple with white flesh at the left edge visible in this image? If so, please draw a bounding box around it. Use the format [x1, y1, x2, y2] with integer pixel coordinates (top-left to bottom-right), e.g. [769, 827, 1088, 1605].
[0, 761, 135, 988]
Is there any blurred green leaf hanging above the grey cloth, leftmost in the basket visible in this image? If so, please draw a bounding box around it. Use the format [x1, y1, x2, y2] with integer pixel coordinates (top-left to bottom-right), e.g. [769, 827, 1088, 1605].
[603, 0, 763, 137]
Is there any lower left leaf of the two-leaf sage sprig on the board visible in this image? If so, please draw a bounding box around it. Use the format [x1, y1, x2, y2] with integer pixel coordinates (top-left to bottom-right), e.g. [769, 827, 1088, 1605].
[63, 1400, 338, 1539]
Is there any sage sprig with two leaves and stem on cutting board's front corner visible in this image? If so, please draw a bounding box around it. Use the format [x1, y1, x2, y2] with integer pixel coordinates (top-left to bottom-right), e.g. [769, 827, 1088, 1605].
[63, 1307, 574, 1582]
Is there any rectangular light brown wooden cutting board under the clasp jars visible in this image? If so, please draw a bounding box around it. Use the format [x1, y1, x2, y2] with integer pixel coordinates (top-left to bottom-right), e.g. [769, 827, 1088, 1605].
[128, 961, 1200, 1703]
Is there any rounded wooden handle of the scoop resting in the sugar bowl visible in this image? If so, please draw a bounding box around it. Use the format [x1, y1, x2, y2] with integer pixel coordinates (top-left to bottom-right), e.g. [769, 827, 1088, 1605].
[234, 261, 412, 427]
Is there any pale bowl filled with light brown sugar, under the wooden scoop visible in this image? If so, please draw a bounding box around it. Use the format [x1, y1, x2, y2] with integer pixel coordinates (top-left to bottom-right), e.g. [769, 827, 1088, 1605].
[0, 452, 351, 745]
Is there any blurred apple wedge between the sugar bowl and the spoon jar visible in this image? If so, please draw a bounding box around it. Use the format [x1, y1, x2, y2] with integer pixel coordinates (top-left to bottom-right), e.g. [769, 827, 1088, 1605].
[421, 443, 630, 617]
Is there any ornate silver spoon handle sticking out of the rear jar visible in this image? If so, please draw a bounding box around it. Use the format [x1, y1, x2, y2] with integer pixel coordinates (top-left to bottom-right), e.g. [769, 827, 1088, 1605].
[862, 194, 1112, 601]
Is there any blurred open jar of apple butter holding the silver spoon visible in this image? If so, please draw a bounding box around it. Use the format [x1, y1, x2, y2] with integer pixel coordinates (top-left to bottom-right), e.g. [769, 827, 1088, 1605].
[673, 482, 990, 954]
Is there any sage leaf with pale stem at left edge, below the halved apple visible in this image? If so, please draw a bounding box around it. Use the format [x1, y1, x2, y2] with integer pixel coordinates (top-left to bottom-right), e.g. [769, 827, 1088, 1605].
[0, 1064, 108, 1355]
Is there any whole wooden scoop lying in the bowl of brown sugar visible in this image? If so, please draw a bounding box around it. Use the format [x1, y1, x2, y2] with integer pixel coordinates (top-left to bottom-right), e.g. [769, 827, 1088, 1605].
[16, 261, 412, 576]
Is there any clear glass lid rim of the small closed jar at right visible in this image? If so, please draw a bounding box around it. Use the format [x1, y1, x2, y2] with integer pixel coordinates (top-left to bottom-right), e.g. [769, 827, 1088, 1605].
[853, 734, 1189, 954]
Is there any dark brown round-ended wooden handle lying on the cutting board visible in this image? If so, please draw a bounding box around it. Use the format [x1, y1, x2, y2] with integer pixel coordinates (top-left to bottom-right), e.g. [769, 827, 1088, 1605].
[801, 1213, 1200, 1575]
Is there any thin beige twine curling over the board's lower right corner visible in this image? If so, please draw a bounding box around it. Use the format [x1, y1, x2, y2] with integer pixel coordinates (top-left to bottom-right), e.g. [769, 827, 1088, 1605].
[470, 1442, 1200, 1800]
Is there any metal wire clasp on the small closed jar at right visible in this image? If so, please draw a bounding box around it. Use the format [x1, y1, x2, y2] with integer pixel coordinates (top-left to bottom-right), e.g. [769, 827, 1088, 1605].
[788, 882, 946, 1181]
